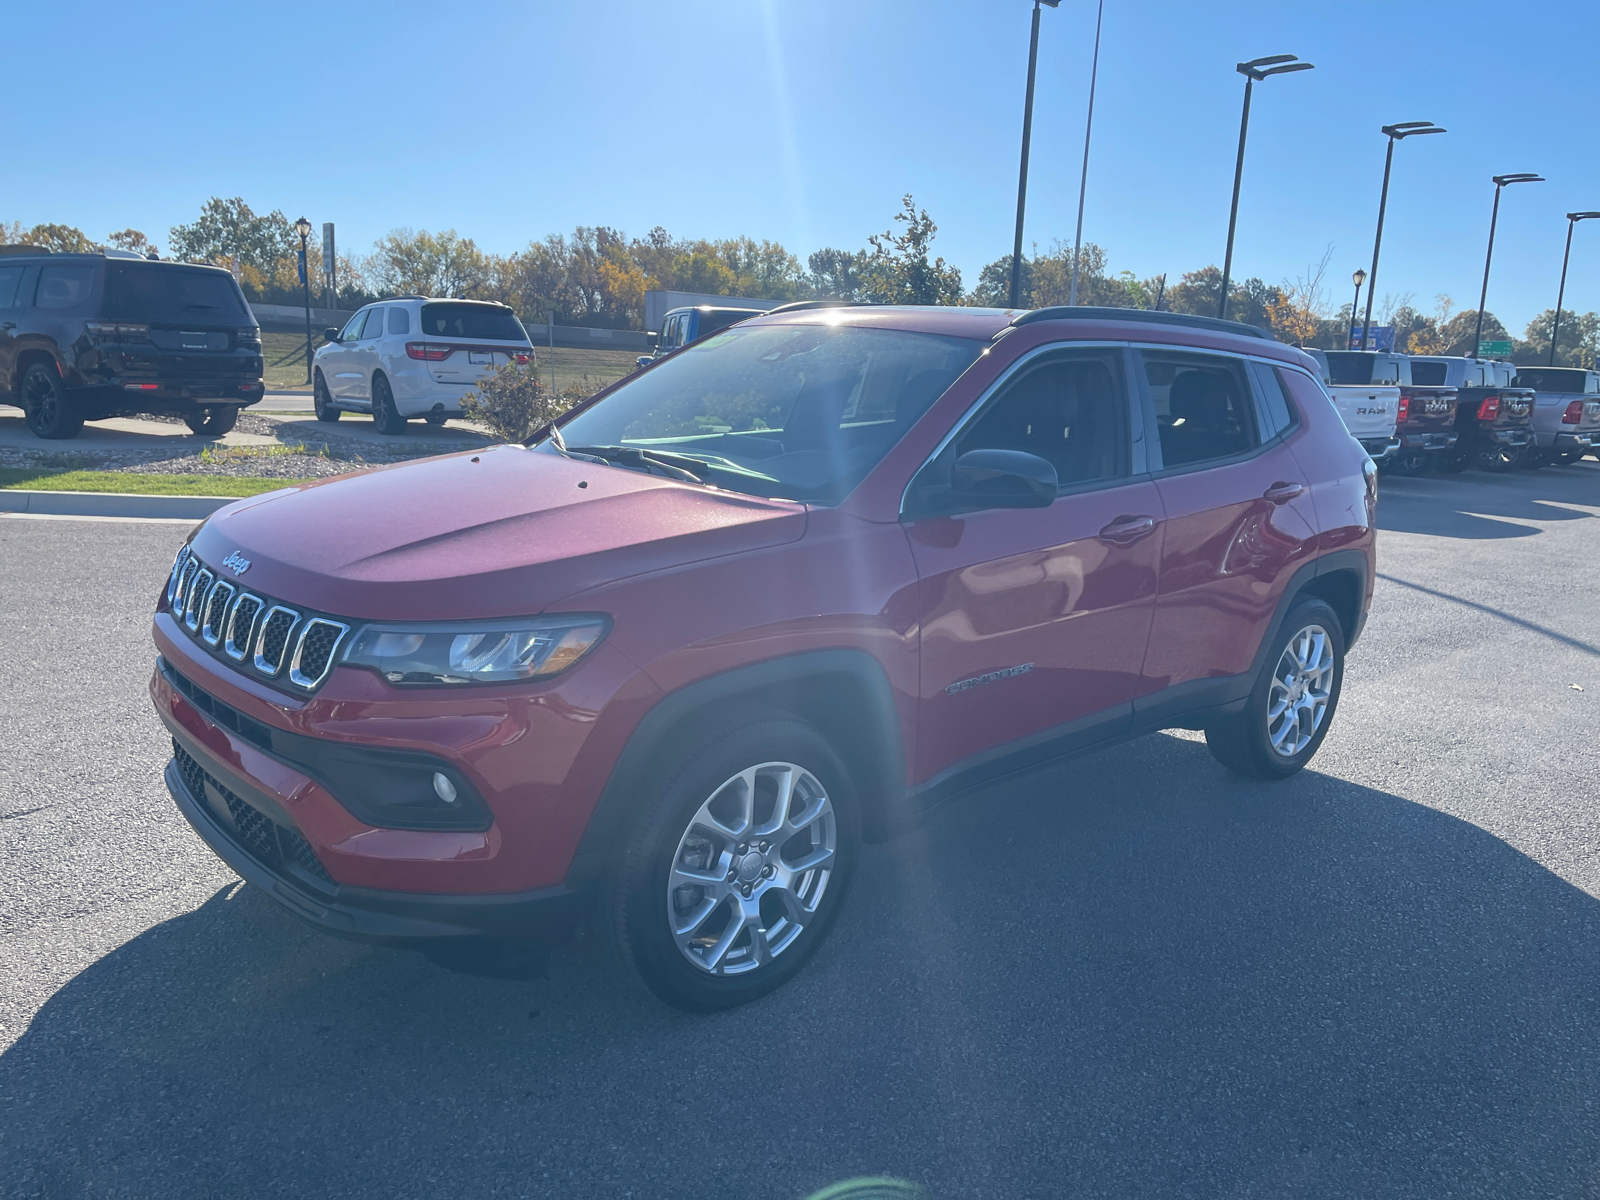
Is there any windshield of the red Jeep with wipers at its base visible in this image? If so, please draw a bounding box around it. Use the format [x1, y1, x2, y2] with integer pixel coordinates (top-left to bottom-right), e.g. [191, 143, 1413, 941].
[546, 325, 982, 504]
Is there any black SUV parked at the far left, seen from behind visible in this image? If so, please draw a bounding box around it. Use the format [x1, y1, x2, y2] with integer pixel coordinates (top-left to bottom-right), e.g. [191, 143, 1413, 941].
[0, 246, 266, 438]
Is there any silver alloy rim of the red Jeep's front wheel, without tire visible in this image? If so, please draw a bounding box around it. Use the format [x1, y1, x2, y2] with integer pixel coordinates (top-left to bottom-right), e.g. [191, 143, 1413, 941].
[667, 763, 838, 976]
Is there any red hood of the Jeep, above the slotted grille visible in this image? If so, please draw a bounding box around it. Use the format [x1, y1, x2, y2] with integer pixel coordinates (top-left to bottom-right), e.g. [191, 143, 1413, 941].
[194, 446, 806, 621]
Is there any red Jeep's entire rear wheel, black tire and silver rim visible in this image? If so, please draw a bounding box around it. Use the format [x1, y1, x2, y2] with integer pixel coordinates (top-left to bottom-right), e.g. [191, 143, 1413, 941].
[1205, 598, 1344, 779]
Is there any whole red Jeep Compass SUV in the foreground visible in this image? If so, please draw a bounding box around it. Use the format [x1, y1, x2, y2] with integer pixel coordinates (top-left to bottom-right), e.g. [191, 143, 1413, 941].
[150, 306, 1376, 1011]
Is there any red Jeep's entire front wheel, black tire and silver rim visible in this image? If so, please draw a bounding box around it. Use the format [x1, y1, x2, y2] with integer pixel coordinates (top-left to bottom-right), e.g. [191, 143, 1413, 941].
[600, 714, 861, 1013]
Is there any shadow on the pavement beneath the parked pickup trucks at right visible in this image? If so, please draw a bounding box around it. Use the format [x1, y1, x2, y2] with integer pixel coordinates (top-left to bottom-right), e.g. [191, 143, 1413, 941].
[1378, 459, 1600, 541]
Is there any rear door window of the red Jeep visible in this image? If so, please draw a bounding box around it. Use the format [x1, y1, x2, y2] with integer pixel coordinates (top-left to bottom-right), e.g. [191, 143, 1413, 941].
[1141, 350, 1261, 467]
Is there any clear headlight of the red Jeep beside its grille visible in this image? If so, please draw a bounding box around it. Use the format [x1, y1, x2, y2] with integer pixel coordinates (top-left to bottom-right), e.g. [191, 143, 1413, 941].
[344, 613, 610, 685]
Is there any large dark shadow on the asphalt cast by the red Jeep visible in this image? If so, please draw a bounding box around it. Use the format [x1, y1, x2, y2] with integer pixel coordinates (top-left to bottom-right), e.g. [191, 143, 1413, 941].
[0, 734, 1600, 1200]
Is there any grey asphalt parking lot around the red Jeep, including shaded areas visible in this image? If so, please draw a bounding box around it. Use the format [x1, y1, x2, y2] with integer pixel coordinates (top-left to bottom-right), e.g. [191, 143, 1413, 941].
[0, 462, 1600, 1200]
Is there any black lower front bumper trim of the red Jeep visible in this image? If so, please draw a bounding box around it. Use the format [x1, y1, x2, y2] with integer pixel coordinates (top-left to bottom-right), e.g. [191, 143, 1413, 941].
[165, 730, 582, 946]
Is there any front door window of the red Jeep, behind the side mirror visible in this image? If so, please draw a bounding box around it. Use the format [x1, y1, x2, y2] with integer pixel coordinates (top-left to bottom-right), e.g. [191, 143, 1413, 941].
[955, 350, 1128, 486]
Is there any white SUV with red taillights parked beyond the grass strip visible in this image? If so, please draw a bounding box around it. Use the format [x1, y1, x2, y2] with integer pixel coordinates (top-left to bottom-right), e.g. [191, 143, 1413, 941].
[312, 296, 533, 434]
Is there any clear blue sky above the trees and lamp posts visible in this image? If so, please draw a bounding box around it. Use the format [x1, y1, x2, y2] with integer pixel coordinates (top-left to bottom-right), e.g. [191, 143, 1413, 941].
[0, 0, 1600, 333]
